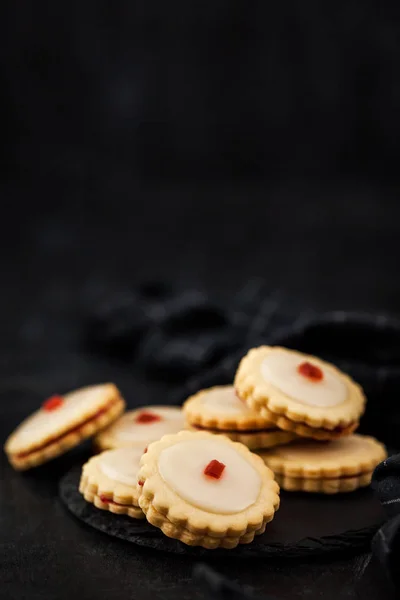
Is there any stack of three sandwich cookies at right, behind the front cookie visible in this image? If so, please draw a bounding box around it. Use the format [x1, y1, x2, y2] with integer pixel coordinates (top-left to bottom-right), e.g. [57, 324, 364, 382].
[184, 346, 386, 493]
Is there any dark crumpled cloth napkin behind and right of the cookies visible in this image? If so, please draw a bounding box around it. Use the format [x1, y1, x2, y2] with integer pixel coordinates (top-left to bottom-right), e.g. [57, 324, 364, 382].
[84, 280, 400, 598]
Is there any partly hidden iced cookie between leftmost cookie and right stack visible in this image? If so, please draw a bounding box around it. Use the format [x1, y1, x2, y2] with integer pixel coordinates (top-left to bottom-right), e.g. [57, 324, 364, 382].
[95, 406, 184, 450]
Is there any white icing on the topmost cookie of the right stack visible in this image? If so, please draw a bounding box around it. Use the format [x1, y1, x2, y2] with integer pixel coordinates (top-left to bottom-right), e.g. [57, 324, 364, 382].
[261, 350, 347, 407]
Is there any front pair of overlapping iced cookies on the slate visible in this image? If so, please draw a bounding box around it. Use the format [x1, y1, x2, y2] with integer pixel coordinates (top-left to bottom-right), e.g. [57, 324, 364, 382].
[79, 431, 279, 549]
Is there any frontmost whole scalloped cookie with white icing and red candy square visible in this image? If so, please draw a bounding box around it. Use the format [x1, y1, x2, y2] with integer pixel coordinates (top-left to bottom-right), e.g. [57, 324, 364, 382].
[138, 431, 279, 549]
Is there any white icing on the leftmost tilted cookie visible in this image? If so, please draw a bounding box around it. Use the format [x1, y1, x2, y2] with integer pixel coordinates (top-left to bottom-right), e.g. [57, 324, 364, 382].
[10, 385, 111, 446]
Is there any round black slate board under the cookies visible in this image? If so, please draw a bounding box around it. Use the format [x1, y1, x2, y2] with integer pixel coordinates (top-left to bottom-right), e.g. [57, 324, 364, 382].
[59, 467, 384, 558]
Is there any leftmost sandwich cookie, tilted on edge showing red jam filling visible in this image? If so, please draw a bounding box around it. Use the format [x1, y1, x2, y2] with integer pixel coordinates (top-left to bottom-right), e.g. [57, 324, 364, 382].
[4, 383, 125, 470]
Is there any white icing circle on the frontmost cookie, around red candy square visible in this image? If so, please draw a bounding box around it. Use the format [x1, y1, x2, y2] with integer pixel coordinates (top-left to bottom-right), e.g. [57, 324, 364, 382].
[158, 439, 261, 514]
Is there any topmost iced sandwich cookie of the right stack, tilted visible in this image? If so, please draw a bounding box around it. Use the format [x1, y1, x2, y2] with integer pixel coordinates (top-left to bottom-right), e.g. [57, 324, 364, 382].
[235, 346, 366, 440]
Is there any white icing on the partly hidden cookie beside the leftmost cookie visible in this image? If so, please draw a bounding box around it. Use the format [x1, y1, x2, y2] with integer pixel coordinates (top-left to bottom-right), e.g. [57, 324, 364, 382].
[110, 406, 184, 449]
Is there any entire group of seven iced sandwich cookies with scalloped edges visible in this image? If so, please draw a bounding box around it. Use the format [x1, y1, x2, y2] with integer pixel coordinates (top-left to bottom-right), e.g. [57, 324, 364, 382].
[5, 346, 386, 549]
